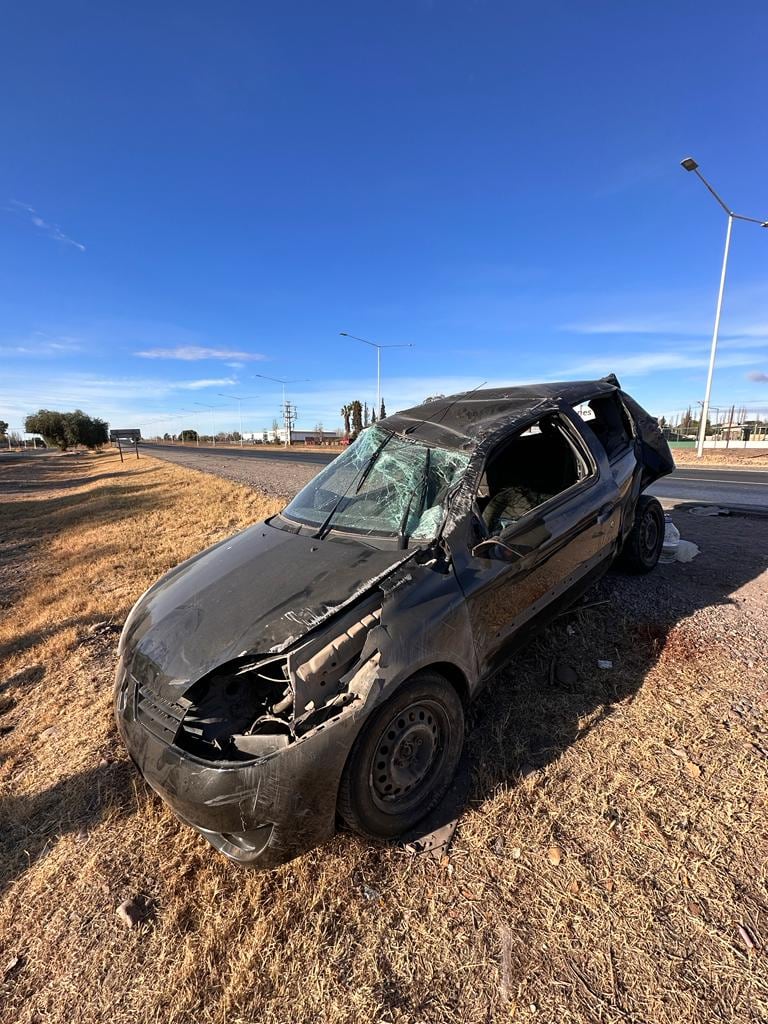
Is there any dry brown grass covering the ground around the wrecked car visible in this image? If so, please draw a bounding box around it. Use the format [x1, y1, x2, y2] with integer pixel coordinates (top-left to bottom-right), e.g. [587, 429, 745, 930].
[0, 453, 768, 1024]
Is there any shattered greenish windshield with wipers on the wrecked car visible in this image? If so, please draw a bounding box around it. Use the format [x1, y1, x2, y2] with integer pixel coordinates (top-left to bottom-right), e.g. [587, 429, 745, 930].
[283, 427, 469, 541]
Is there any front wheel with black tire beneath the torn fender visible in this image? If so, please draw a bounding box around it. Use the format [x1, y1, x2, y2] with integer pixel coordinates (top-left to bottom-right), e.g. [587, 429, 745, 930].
[338, 671, 464, 839]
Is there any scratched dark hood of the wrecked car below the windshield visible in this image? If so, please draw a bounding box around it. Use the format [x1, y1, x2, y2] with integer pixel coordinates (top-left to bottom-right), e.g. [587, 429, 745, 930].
[121, 523, 413, 697]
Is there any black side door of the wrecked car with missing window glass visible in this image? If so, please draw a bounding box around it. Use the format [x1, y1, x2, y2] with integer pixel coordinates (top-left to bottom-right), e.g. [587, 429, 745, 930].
[452, 407, 620, 675]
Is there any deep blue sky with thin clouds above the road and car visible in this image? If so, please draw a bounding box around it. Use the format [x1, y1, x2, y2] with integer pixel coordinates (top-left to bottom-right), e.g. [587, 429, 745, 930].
[0, 0, 768, 433]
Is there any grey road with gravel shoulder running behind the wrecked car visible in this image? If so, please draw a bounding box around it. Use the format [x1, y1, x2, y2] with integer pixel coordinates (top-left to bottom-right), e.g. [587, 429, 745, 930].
[142, 443, 768, 509]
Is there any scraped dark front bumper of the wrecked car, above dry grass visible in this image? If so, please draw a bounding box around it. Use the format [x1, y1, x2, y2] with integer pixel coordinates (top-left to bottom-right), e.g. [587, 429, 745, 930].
[116, 665, 370, 868]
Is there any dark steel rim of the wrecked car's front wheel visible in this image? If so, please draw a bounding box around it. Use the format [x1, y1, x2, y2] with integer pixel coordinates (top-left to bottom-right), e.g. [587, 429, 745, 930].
[369, 699, 451, 814]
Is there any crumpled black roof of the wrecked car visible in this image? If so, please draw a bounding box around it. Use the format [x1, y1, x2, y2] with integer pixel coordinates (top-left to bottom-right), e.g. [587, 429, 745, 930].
[380, 374, 620, 447]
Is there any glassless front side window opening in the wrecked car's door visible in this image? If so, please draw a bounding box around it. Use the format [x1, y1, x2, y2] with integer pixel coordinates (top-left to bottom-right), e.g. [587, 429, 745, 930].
[475, 416, 592, 537]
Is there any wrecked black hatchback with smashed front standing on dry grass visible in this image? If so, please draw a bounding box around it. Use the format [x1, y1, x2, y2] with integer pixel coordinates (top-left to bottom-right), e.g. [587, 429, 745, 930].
[116, 376, 674, 867]
